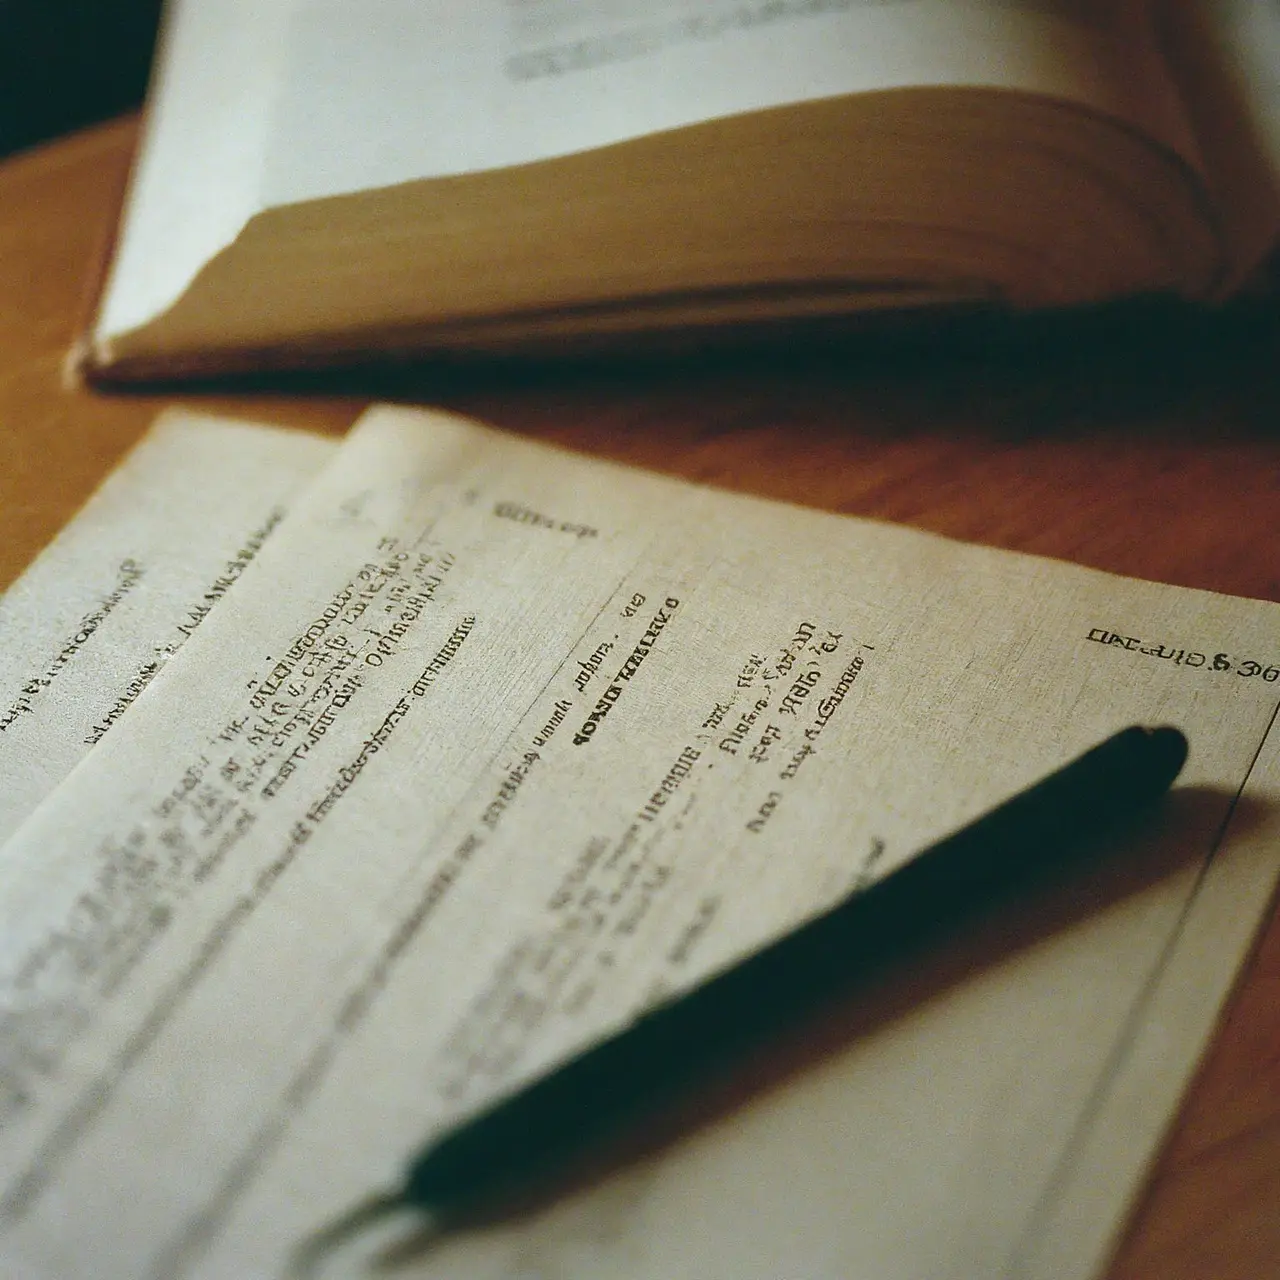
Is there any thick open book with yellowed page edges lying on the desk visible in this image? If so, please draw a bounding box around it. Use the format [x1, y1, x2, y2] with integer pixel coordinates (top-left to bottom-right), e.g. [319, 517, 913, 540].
[77, 0, 1280, 380]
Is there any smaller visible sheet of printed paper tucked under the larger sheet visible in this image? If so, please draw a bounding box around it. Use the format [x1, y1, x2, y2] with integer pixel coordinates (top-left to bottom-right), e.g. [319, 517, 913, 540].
[0, 413, 334, 841]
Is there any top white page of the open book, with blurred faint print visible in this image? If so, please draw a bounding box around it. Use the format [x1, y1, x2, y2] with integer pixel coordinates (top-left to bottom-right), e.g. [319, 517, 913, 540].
[264, 0, 1187, 205]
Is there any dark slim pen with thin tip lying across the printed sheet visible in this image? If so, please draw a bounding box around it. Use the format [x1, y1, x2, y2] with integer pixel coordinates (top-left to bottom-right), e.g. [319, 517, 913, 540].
[296, 726, 1187, 1272]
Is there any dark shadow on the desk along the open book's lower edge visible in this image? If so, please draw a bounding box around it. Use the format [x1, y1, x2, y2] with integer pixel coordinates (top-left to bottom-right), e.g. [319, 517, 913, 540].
[105, 293, 1280, 439]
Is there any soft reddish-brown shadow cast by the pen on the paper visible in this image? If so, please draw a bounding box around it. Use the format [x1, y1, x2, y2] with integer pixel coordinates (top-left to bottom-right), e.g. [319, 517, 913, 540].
[374, 787, 1268, 1274]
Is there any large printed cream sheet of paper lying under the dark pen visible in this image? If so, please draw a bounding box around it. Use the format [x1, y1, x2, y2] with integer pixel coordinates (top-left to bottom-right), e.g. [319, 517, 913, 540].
[0, 410, 1280, 1280]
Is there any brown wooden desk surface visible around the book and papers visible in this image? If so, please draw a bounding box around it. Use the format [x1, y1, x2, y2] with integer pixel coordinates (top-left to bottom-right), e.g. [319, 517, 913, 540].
[0, 122, 1280, 1280]
